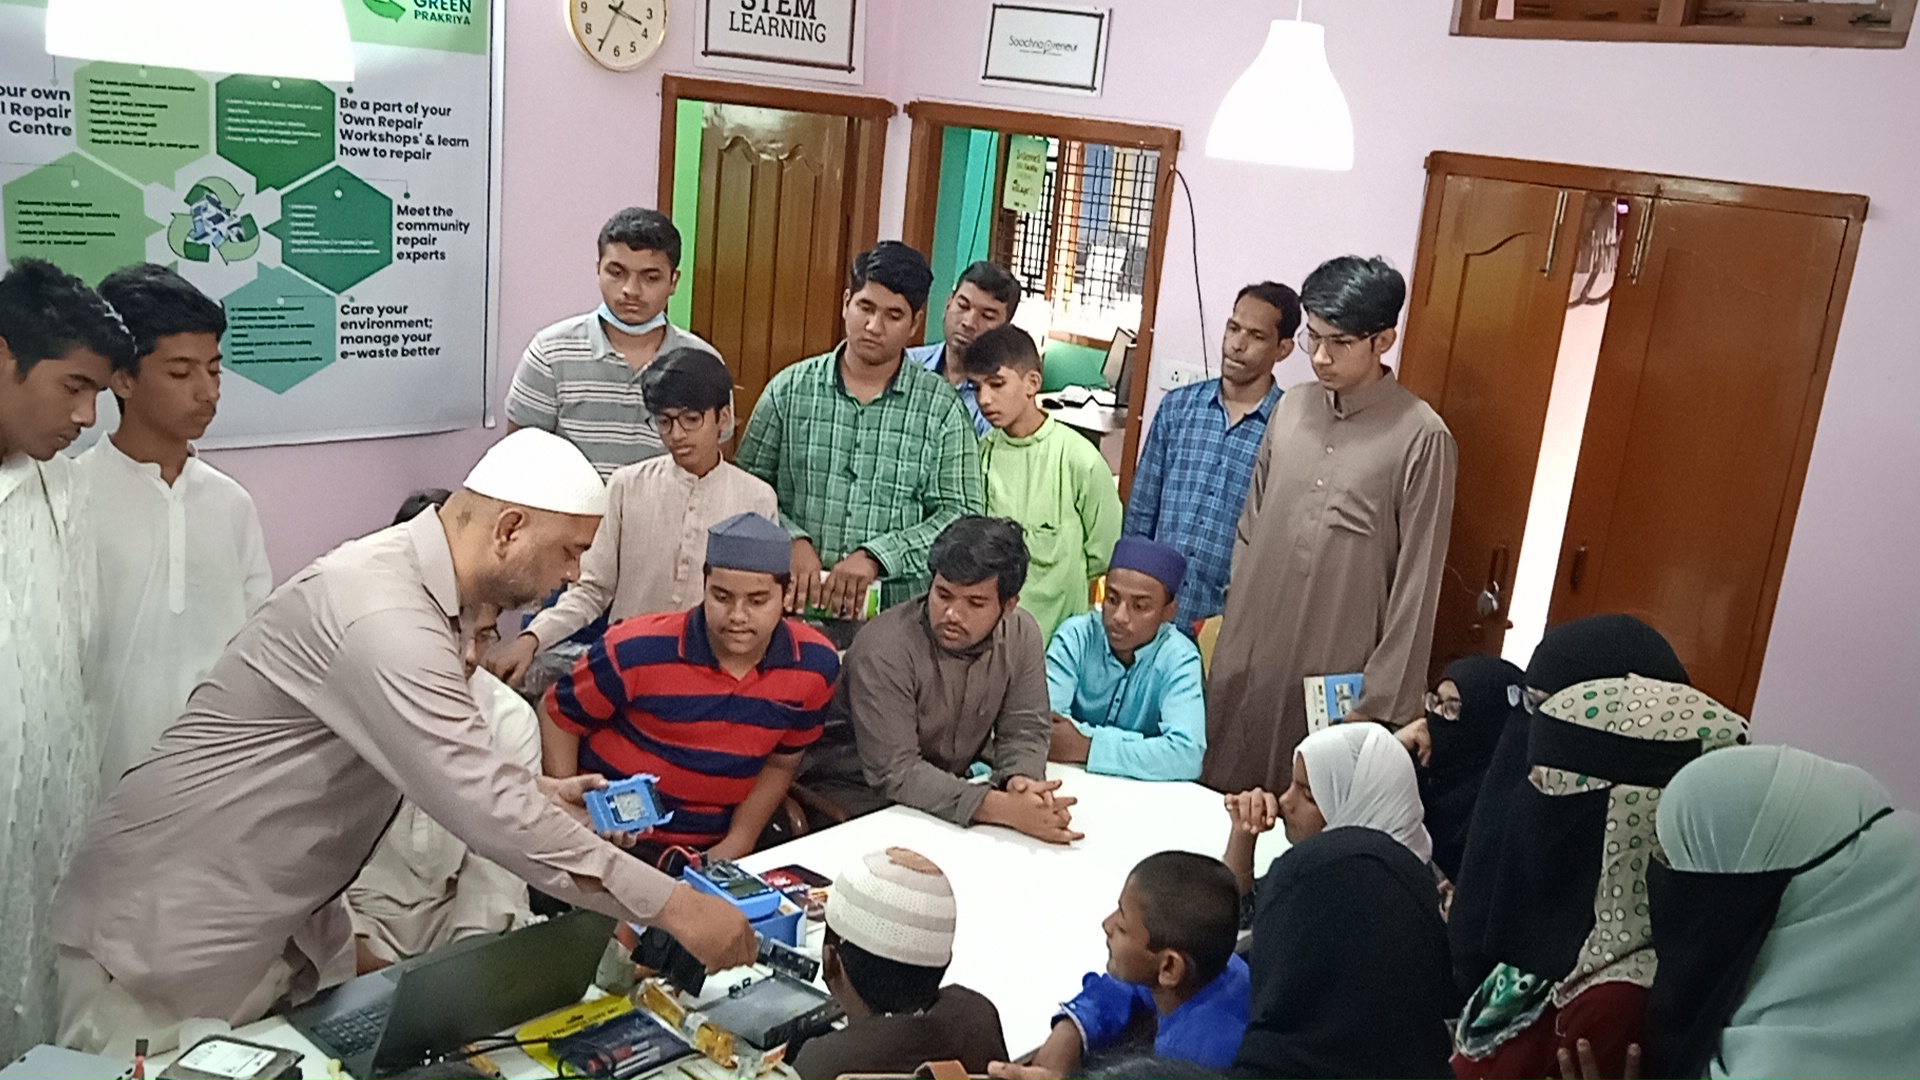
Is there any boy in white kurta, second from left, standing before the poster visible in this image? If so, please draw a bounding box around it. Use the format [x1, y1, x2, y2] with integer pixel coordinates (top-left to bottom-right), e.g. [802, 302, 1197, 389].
[79, 263, 273, 788]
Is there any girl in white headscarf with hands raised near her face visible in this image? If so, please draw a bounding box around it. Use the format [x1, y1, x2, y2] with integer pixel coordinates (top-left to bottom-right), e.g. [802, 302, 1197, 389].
[1223, 723, 1434, 896]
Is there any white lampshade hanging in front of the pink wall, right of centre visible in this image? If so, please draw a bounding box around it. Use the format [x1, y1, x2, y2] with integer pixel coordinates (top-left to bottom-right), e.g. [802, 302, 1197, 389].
[1206, 19, 1354, 171]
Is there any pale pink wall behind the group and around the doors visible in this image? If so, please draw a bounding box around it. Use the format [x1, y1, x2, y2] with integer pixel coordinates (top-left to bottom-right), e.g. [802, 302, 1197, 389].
[215, 0, 1920, 805]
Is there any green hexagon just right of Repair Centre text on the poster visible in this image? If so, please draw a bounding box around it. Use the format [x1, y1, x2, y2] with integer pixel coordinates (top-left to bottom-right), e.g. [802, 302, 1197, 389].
[73, 63, 211, 188]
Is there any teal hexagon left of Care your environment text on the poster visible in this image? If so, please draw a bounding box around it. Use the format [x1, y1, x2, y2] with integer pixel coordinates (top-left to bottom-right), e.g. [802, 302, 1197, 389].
[221, 267, 338, 394]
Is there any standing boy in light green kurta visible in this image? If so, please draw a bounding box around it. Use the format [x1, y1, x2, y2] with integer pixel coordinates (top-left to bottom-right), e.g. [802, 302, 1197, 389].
[964, 327, 1121, 640]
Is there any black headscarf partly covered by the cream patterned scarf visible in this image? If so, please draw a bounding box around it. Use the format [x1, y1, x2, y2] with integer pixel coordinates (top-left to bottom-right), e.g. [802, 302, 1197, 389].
[1448, 615, 1688, 994]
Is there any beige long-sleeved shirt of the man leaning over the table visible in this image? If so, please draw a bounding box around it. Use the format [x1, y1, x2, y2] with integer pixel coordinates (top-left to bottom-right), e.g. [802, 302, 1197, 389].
[54, 513, 674, 1024]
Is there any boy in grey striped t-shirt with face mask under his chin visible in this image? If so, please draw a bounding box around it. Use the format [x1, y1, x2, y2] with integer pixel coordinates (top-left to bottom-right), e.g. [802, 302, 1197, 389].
[507, 206, 720, 479]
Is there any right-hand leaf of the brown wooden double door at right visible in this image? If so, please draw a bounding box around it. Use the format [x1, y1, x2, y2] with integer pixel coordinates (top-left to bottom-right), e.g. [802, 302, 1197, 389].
[1549, 198, 1864, 711]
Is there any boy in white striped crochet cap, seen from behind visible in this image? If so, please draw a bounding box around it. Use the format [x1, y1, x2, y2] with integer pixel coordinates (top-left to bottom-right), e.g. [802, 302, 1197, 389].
[793, 847, 1006, 1080]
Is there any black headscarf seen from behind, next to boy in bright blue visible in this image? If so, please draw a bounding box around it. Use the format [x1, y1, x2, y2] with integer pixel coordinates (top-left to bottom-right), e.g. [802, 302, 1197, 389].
[1227, 826, 1459, 1080]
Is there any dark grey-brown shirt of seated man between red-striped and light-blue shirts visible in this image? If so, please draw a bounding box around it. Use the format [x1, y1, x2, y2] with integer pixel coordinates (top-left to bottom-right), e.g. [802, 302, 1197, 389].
[839, 598, 1052, 824]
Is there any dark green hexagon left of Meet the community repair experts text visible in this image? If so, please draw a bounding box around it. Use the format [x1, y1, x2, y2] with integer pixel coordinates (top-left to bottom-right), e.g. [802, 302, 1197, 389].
[267, 165, 394, 292]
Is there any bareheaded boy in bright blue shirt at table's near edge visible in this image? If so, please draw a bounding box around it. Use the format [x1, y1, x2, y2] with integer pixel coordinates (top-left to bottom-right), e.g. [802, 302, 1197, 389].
[989, 851, 1252, 1080]
